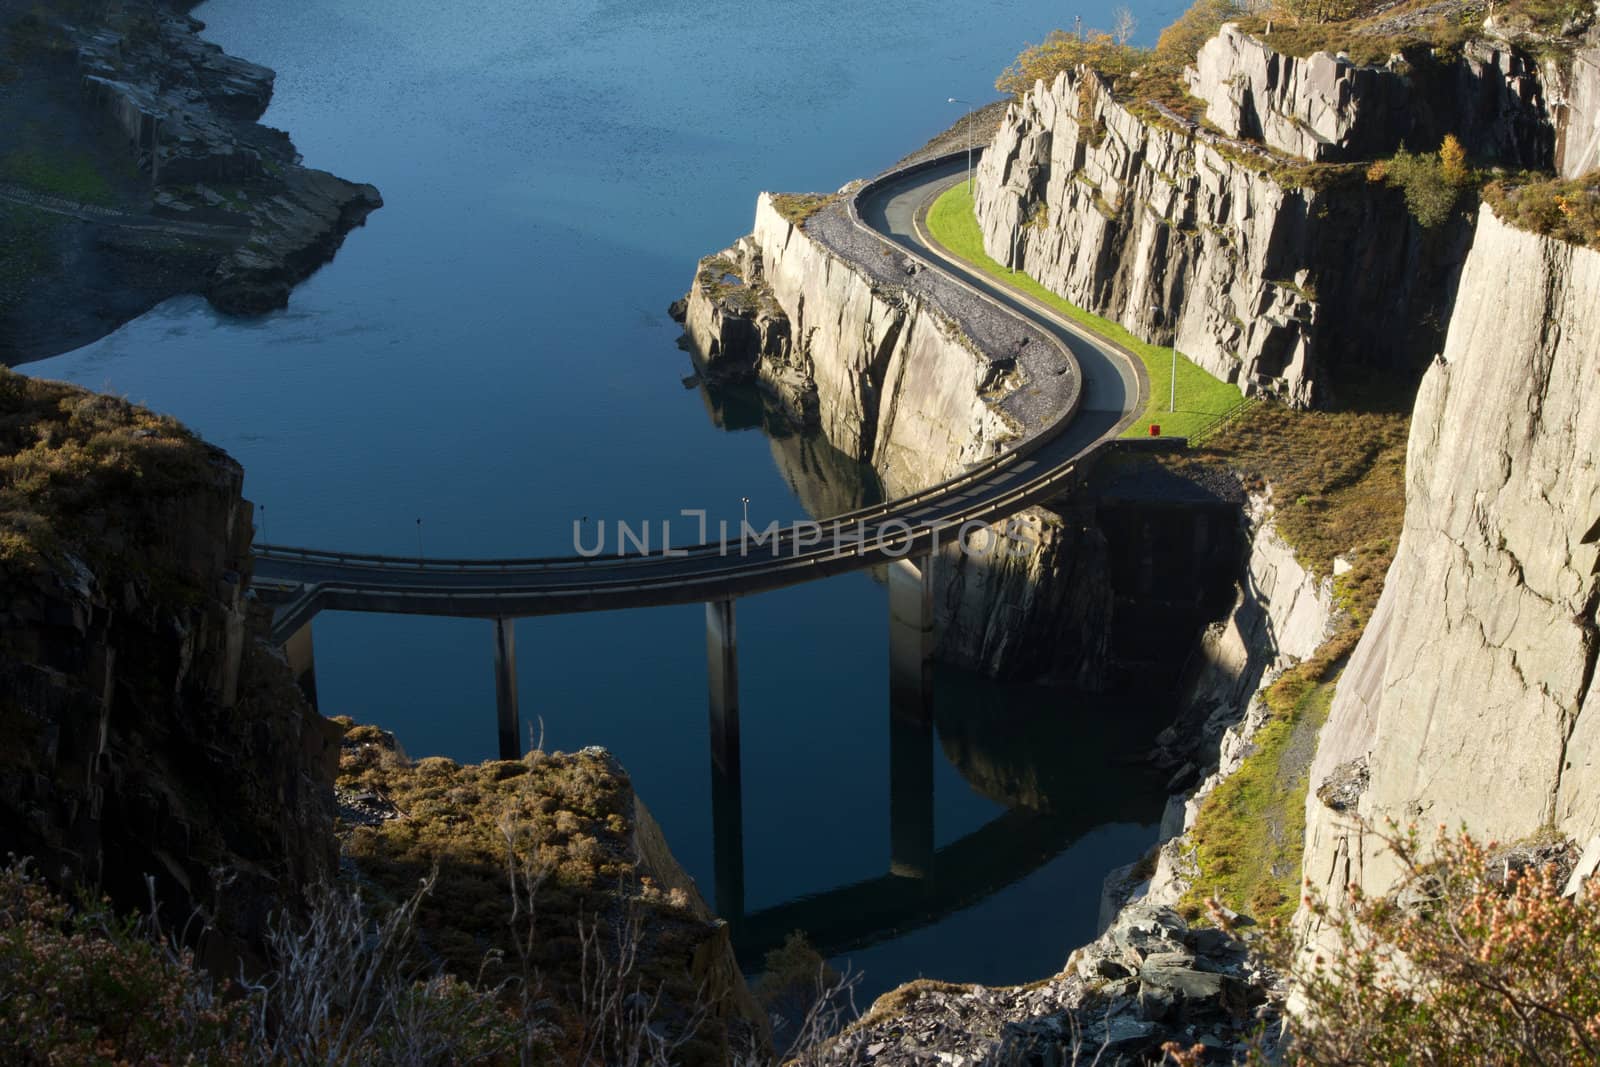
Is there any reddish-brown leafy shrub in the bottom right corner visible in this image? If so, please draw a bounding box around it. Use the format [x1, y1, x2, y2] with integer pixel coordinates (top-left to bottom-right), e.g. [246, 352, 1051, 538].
[1274, 827, 1600, 1065]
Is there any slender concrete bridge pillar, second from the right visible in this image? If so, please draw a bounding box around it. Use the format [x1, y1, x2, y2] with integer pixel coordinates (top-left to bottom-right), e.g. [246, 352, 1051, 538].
[706, 600, 744, 929]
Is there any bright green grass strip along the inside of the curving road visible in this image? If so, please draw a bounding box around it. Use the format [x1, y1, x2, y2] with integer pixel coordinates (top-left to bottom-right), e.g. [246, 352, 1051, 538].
[928, 184, 1242, 437]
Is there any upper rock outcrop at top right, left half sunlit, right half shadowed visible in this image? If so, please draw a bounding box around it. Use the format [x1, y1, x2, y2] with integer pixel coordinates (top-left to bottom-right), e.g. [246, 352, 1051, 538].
[1187, 24, 1554, 166]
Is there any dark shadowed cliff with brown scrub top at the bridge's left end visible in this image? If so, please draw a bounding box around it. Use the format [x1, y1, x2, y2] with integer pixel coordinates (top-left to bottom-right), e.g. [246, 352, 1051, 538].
[0, 371, 338, 971]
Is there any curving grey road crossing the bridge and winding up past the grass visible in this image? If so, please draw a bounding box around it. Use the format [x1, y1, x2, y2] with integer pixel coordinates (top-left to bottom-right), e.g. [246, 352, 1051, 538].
[253, 154, 1149, 641]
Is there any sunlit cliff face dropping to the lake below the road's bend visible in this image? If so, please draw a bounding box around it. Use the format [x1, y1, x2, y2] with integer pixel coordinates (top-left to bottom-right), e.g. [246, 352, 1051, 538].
[685, 194, 1021, 496]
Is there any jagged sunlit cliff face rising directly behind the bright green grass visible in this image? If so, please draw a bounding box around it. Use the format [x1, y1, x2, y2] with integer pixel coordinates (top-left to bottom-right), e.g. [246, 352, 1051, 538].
[978, 67, 1466, 405]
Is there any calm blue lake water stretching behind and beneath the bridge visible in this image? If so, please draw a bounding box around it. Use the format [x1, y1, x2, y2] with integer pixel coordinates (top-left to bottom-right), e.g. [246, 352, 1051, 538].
[27, 0, 1176, 993]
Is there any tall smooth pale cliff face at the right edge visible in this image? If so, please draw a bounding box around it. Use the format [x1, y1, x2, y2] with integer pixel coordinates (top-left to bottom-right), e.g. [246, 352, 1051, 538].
[1306, 206, 1600, 934]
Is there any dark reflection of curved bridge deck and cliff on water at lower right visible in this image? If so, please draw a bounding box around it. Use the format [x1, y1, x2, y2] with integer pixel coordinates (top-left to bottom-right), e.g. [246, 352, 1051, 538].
[725, 670, 1171, 968]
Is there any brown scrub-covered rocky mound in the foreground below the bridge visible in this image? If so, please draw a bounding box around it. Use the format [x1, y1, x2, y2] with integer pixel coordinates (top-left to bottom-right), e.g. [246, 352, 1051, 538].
[338, 726, 728, 1064]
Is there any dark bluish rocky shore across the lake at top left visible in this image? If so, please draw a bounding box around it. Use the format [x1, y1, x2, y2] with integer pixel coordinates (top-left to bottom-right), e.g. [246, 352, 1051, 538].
[0, 0, 382, 365]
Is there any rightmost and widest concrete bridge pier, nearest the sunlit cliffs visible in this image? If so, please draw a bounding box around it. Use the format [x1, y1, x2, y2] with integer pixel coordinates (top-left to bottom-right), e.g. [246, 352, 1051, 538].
[890, 555, 933, 878]
